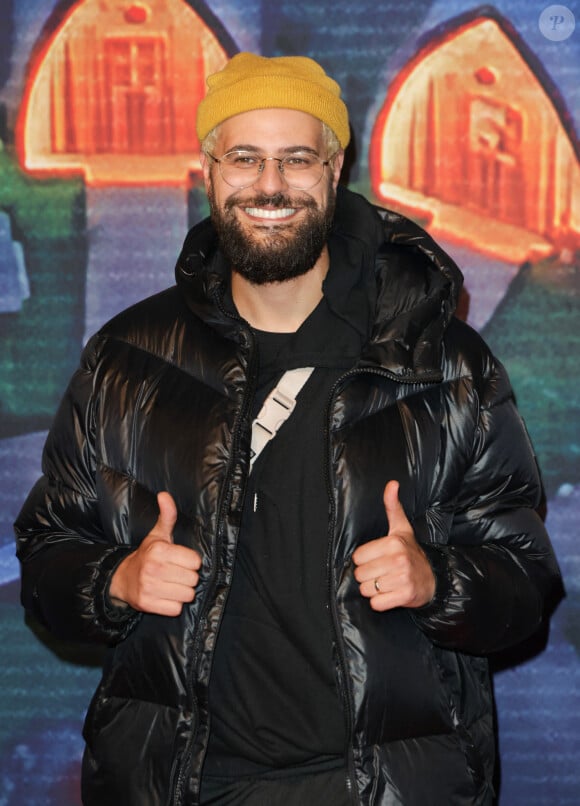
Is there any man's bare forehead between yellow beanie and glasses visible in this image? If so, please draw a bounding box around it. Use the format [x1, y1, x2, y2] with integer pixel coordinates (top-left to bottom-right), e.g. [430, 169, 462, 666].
[218, 109, 323, 153]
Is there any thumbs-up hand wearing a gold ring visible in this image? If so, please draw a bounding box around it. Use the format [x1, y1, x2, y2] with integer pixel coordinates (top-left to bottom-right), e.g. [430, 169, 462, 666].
[352, 481, 435, 611]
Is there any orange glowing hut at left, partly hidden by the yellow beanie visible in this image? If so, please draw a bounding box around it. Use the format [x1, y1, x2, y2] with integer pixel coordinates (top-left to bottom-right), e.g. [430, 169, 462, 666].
[17, 0, 228, 184]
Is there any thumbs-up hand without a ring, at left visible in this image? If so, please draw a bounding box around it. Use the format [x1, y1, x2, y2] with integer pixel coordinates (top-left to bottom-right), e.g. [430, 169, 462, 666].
[109, 492, 201, 616]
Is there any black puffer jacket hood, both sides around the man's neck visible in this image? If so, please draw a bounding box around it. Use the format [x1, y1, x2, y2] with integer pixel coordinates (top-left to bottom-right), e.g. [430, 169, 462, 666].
[175, 186, 463, 381]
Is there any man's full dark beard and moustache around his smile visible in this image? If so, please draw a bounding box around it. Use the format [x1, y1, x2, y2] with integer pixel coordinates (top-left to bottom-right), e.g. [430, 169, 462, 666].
[208, 185, 336, 285]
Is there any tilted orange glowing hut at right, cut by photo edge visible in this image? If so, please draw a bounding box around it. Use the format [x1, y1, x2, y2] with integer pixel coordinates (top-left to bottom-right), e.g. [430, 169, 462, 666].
[370, 10, 580, 260]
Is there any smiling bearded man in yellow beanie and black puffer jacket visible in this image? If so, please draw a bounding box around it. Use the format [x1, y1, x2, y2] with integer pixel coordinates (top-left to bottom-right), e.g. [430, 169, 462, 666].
[16, 53, 559, 806]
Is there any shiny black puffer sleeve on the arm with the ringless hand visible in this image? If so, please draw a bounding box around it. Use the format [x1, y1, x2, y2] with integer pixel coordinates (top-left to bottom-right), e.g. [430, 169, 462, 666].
[15, 336, 139, 643]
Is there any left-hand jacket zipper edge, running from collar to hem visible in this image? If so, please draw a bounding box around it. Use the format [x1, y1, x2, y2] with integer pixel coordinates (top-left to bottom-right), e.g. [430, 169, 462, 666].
[173, 289, 256, 806]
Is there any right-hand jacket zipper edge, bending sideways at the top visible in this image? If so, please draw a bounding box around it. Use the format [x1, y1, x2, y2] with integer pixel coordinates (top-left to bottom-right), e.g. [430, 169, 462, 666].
[324, 367, 440, 806]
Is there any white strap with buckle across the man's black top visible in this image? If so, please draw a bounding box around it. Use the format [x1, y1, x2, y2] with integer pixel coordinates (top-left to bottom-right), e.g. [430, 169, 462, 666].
[250, 367, 314, 471]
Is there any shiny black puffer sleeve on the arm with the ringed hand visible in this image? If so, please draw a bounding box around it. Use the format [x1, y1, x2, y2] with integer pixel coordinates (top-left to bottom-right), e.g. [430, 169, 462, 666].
[413, 346, 562, 655]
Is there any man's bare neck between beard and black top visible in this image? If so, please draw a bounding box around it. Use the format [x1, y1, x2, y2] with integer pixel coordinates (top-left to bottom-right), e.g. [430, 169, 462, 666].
[232, 248, 329, 333]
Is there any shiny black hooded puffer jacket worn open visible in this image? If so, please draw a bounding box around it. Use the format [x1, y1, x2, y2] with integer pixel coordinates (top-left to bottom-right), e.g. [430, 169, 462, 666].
[16, 190, 558, 806]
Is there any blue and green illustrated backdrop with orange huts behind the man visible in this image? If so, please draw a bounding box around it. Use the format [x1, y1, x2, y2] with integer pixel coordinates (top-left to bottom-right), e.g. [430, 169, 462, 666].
[0, 0, 580, 806]
